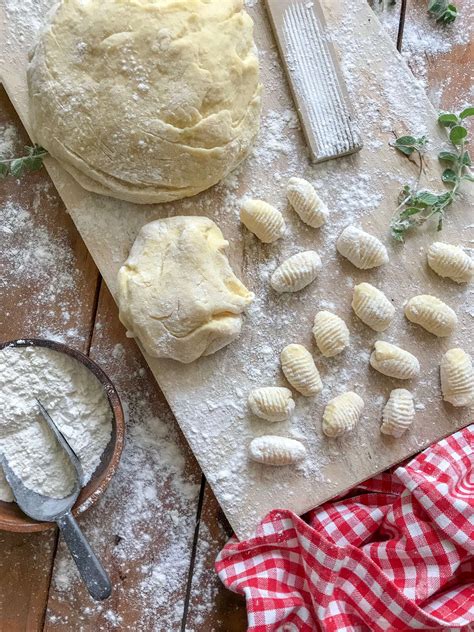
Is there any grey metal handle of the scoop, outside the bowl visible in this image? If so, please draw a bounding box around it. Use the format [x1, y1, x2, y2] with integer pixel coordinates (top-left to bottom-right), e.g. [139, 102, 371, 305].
[56, 512, 112, 601]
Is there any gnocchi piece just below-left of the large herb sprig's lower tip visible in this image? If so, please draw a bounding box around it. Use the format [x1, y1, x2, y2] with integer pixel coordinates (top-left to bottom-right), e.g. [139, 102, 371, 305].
[336, 226, 388, 270]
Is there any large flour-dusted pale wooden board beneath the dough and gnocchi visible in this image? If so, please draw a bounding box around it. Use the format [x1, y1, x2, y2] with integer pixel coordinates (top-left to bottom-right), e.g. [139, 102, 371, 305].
[0, 0, 473, 537]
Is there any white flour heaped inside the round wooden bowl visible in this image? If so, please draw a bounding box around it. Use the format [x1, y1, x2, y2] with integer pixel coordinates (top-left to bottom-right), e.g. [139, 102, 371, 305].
[0, 347, 112, 501]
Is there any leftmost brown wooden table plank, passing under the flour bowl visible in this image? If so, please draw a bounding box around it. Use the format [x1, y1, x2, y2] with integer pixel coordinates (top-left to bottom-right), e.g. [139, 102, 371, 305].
[0, 86, 98, 632]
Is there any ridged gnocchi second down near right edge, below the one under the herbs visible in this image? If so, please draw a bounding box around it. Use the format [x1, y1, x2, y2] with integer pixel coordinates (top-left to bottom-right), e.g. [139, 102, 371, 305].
[405, 294, 458, 337]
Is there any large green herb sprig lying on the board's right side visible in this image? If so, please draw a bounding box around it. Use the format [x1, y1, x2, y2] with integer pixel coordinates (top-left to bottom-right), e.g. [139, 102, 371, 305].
[390, 107, 474, 241]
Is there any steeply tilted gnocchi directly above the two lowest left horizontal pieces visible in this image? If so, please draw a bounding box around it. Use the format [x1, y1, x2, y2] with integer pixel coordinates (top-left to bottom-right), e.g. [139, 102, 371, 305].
[280, 344, 323, 397]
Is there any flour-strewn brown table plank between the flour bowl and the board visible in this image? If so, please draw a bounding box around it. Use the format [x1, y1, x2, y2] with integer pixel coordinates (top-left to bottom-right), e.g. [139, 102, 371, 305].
[45, 286, 205, 632]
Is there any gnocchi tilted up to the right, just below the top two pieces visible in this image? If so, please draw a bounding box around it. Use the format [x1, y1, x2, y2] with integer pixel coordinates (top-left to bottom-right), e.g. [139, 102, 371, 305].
[270, 250, 322, 294]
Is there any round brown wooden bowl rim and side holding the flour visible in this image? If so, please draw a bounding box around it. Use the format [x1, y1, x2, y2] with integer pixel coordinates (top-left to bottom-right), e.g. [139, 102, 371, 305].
[0, 338, 125, 533]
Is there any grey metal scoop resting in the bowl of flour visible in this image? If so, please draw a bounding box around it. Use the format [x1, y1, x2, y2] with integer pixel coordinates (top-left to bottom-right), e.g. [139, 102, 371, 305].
[0, 400, 112, 601]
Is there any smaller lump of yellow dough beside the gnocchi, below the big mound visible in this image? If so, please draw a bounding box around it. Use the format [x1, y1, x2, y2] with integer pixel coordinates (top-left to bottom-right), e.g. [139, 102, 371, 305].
[117, 217, 254, 363]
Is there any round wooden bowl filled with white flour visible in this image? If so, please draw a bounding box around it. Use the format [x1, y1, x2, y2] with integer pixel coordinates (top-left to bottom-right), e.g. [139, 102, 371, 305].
[0, 339, 125, 532]
